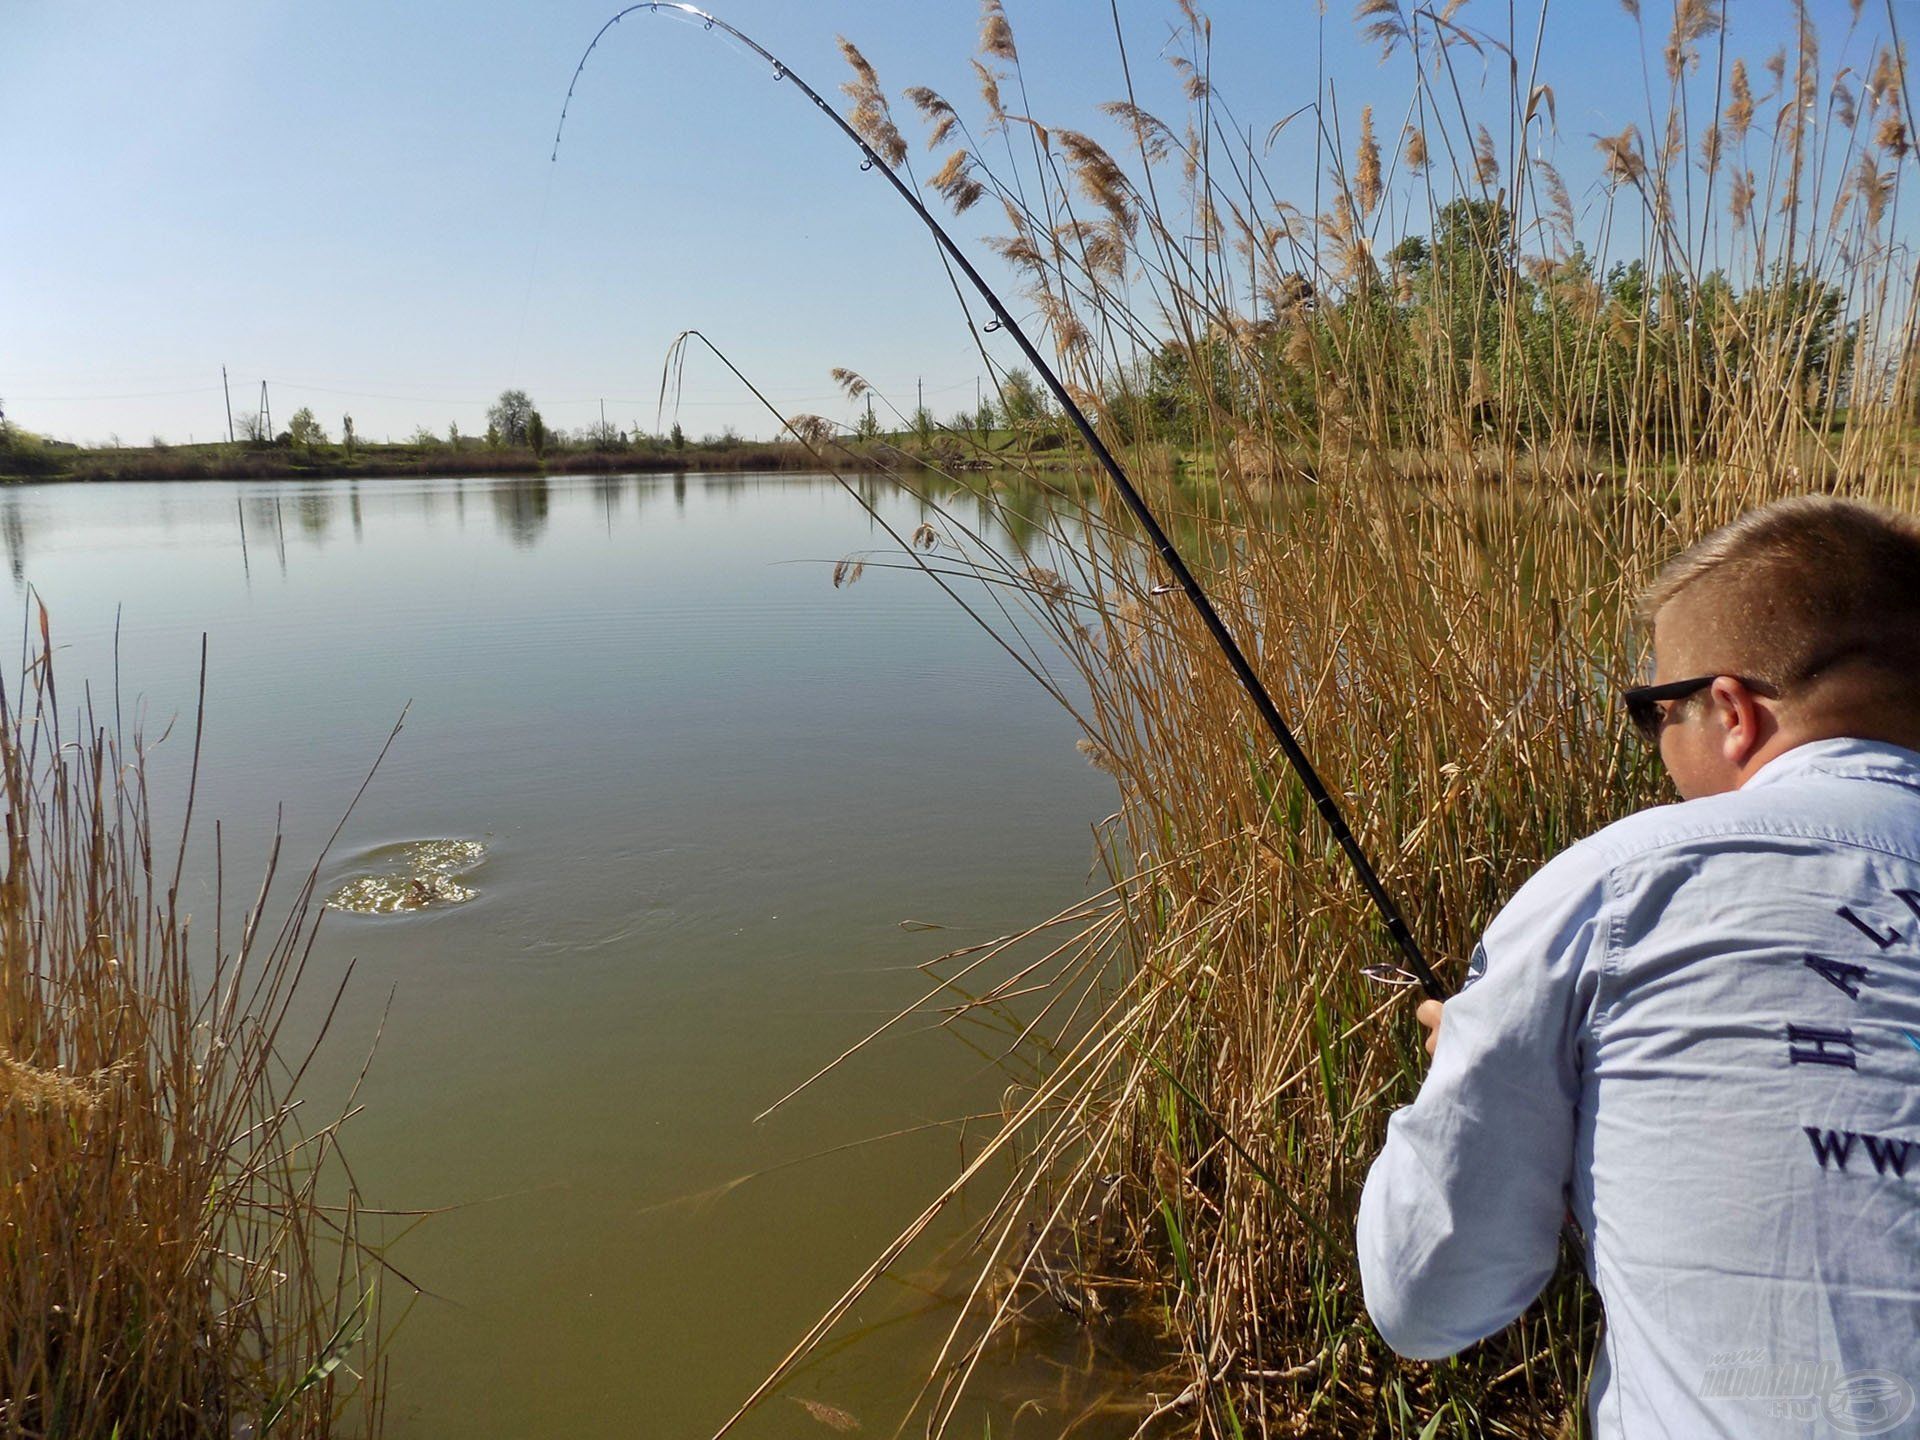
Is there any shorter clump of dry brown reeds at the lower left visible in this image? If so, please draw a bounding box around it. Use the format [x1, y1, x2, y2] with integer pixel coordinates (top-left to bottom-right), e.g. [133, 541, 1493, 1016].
[0, 616, 382, 1440]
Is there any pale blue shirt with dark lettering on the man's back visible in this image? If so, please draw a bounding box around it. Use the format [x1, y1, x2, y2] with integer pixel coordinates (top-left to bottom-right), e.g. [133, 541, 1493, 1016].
[1359, 739, 1920, 1440]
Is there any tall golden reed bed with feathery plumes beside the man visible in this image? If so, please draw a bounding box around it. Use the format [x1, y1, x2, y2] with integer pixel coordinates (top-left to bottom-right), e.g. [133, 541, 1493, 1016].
[729, 0, 1920, 1440]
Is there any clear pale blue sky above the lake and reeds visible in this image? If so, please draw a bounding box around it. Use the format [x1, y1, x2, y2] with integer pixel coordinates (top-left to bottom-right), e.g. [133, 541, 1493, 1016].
[0, 0, 1896, 444]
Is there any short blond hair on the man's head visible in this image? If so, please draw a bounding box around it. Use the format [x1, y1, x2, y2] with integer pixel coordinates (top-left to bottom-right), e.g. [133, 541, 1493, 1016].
[1640, 495, 1920, 708]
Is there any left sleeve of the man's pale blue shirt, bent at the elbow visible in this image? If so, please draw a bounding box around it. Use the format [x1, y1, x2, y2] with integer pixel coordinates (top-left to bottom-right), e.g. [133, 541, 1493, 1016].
[1357, 847, 1605, 1359]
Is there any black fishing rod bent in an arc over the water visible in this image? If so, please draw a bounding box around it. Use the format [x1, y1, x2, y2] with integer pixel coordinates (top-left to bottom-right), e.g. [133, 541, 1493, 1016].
[549, 0, 1448, 1000]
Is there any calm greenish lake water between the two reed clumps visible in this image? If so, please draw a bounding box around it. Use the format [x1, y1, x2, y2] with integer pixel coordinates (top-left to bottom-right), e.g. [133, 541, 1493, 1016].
[0, 476, 1114, 1440]
